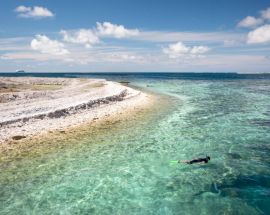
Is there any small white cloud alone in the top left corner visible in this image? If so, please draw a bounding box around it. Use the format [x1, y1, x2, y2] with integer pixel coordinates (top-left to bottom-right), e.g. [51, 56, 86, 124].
[15, 5, 54, 18]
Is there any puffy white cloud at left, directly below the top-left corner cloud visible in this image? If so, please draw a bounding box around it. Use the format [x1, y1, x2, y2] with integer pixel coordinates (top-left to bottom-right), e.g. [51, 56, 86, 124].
[31, 35, 69, 55]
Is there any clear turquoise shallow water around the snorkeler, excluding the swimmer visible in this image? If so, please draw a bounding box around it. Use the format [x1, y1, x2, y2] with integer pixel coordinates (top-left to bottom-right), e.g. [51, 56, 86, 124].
[0, 73, 270, 214]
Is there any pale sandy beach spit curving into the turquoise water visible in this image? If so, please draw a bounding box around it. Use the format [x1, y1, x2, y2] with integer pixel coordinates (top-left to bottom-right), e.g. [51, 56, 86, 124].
[0, 77, 151, 148]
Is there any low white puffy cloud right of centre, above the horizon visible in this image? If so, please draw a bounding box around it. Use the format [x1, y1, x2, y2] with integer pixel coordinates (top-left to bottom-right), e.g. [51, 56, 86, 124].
[162, 42, 210, 59]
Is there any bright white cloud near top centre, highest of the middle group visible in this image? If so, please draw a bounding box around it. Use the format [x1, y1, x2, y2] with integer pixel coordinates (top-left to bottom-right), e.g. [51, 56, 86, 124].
[97, 22, 139, 38]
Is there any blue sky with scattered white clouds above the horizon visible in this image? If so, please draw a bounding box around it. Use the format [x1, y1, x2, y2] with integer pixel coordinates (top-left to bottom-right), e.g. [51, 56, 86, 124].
[0, 0, 270, 73]
